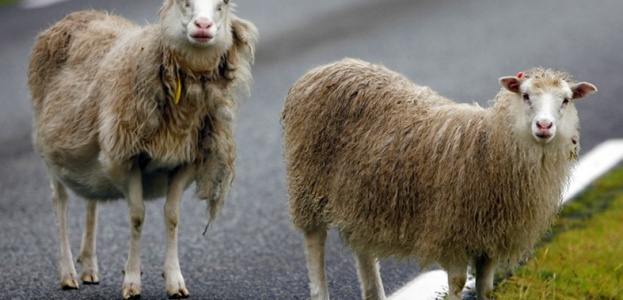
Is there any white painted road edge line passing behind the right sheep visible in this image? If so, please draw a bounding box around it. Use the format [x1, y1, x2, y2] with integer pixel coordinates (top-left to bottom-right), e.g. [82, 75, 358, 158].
[389, 139, 623, 300]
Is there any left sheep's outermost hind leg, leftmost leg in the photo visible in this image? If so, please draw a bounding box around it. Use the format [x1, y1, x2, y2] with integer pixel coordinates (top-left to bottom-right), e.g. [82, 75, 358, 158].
[50, 179, 80, 289]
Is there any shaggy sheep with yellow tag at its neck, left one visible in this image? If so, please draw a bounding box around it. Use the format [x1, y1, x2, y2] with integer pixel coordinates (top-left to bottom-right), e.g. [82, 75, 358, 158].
[28, 0, 258, 299]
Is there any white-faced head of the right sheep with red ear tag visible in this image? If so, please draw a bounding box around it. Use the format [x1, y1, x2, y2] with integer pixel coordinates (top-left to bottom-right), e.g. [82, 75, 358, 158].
[500, 68, 597, 144]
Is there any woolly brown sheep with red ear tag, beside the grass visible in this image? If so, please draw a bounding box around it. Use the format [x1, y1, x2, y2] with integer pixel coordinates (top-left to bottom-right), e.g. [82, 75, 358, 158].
[281, 59, 597, 299]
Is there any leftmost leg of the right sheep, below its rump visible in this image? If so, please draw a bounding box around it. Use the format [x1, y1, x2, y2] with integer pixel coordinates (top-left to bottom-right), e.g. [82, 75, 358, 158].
[305, 228, 329, 300]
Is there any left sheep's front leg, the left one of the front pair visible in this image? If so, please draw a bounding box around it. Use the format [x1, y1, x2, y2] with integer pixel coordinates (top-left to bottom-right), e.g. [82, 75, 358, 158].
[121, 164, 145, 299]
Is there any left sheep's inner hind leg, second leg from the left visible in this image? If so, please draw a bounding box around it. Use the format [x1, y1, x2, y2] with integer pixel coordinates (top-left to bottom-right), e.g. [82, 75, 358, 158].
[78, 200, 99, 284]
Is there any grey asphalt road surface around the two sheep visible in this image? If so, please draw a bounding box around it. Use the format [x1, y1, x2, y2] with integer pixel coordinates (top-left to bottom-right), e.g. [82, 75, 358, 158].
[0, 0, 623, 299]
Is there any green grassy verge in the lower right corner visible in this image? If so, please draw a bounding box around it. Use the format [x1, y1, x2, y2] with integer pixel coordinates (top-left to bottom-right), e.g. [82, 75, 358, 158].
[496, 167, 623, 299]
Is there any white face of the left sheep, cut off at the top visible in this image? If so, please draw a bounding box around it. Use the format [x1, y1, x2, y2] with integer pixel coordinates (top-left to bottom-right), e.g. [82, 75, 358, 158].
[160, 0, 231, 48]
